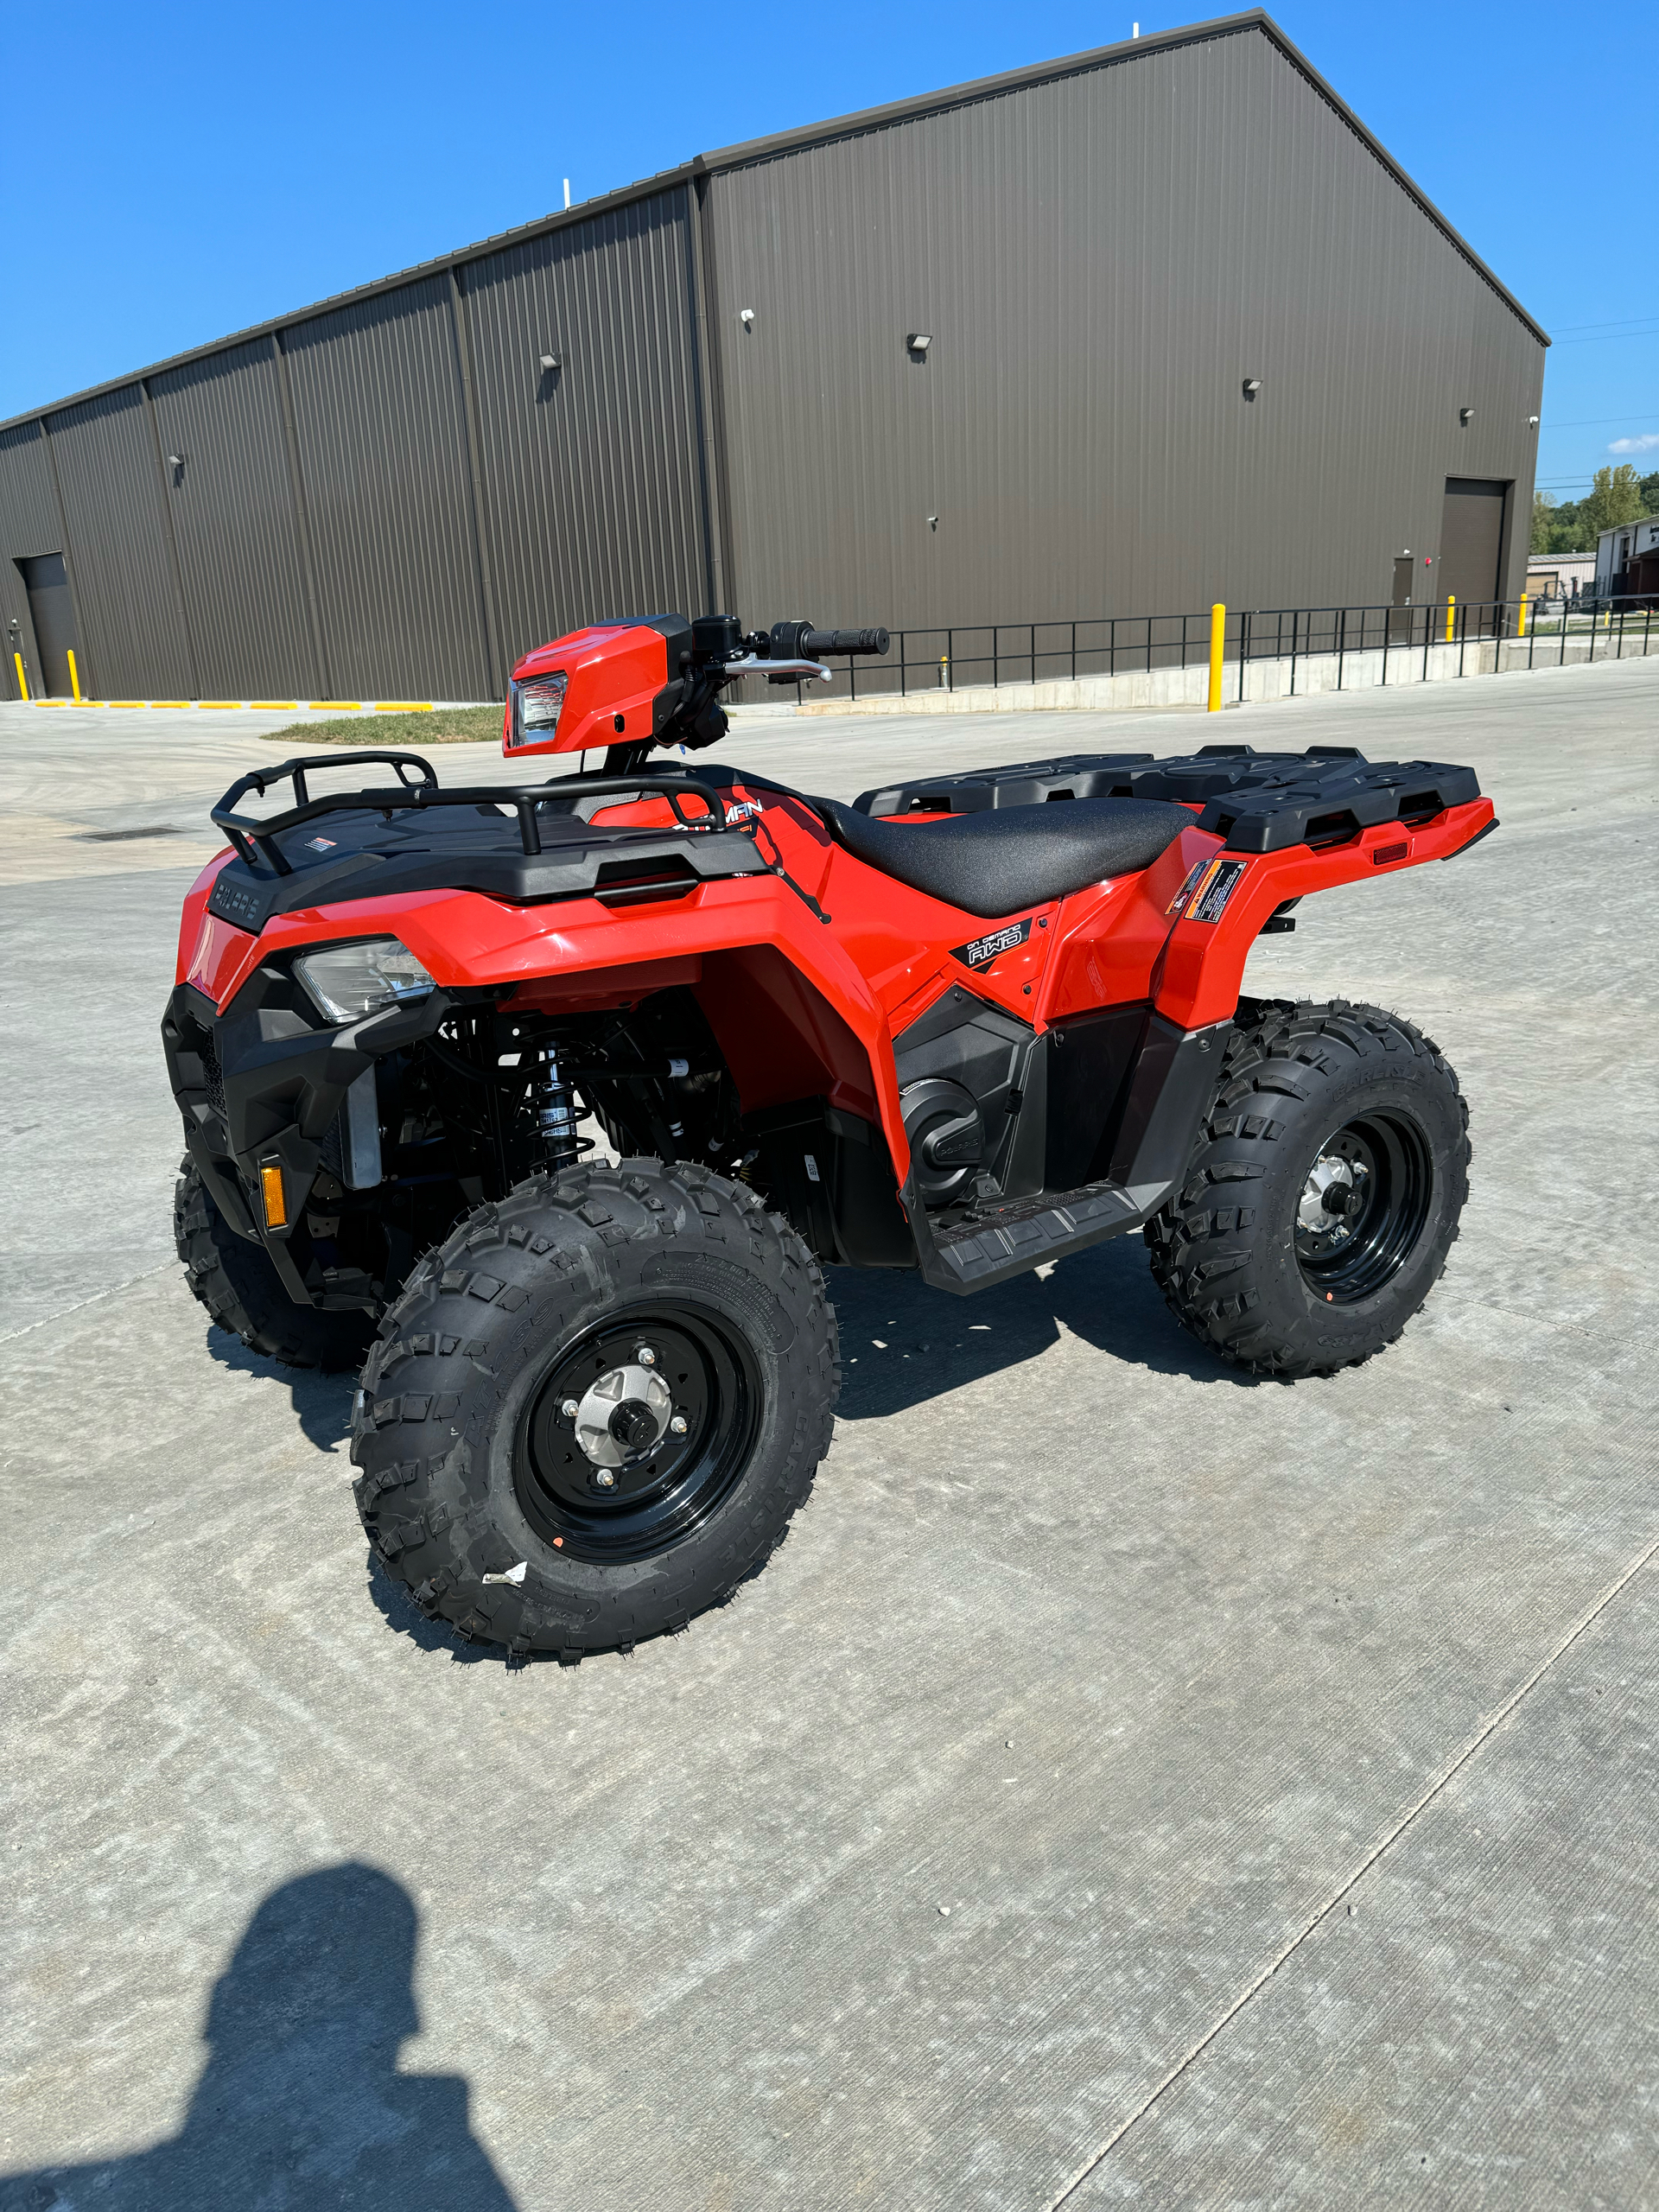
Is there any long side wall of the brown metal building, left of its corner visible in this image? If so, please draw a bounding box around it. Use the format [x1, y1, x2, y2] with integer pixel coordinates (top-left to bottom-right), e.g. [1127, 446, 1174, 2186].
[0, 202, 708, 699]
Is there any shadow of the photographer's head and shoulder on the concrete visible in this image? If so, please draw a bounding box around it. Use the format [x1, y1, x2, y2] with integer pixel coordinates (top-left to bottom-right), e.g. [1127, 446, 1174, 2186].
[0, 1863, 515, 2212]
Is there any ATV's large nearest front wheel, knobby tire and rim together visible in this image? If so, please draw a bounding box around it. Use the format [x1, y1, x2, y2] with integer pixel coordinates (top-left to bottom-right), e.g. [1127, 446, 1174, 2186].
[352, 1159, 838, 1659]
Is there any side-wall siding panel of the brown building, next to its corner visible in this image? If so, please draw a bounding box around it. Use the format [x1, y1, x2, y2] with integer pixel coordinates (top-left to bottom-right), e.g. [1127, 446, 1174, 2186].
[460, 190, 706, 664]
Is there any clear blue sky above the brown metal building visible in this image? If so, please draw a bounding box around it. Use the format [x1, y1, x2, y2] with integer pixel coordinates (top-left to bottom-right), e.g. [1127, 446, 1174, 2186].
[0, 0, 1659, 498]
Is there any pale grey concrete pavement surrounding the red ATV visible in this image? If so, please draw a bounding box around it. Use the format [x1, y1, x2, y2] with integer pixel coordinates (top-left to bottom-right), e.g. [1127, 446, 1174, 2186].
[0, 664, 1659, 2212]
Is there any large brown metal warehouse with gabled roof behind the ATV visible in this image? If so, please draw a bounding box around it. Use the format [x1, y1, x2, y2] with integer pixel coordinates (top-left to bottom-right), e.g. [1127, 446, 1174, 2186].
[0, 11, 1548, 699]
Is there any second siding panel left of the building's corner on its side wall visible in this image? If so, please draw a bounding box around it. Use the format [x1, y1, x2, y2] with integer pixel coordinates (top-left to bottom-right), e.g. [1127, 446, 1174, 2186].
[283, 276, 489, 699]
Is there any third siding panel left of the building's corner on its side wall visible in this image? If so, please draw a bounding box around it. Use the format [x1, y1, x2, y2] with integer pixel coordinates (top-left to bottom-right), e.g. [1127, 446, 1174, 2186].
[150, 339, 323, 699]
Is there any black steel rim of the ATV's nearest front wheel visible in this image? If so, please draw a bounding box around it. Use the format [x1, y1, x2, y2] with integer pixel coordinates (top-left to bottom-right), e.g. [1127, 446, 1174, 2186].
[513, 1303, 761, 1564]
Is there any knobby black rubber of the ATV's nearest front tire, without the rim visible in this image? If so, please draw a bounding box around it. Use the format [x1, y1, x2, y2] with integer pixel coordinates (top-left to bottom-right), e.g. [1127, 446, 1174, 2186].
[352, 1159, 841, 1662]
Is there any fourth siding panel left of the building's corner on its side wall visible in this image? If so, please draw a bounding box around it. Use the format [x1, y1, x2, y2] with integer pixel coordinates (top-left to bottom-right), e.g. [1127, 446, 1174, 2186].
[47, 385, 193, 699]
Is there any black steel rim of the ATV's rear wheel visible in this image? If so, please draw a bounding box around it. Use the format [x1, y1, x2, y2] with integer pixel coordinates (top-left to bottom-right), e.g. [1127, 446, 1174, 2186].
[1294, 1113, 1433, 1305]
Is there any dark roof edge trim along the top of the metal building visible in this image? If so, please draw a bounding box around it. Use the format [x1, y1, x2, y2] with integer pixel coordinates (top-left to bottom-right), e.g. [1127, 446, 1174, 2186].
[0, 9, 1551, 431]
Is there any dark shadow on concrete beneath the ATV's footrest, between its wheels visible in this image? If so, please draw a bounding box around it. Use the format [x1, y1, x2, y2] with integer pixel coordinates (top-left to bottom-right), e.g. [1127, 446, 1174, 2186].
[827, 1236, 1261, 1421]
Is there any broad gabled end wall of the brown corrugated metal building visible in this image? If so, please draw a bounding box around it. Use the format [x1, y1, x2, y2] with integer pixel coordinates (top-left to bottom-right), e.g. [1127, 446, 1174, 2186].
[710, 29, 1541, 626]
